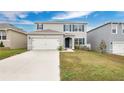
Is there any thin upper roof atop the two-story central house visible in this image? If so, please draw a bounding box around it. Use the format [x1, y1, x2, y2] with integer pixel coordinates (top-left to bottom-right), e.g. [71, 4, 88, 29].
[35, 21, 87, 24]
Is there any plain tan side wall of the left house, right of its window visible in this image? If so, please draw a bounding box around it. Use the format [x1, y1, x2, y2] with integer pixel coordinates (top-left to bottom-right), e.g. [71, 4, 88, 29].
[8, 30, 27, 49]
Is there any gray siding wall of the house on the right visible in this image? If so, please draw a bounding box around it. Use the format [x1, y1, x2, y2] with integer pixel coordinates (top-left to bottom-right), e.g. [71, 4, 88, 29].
[87, 23, 124, 53]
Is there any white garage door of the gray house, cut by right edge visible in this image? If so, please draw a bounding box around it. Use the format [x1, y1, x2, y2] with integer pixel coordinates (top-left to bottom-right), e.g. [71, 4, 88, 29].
[113, 42, 124, 54]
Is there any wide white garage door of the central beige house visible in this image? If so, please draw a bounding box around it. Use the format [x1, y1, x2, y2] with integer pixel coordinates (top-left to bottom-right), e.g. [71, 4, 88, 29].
[32, 39, 59, 50]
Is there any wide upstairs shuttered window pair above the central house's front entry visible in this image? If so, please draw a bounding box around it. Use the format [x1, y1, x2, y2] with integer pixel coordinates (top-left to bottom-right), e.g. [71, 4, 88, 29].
[64, 24, 84, 32]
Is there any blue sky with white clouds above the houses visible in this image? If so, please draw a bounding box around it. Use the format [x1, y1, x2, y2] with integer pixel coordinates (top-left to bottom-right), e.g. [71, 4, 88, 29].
[0, 11, 124, 32]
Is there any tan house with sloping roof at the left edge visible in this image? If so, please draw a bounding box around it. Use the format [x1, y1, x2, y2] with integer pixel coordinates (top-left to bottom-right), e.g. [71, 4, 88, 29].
[0, 23, 27, 49]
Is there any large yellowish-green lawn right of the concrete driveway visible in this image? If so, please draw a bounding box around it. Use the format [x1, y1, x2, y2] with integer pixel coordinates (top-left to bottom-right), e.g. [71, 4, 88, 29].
[60, 51, 124, 81]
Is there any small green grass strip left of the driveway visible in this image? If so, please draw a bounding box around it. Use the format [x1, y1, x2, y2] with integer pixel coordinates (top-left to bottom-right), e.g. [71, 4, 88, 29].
[0, 49, 26, 59]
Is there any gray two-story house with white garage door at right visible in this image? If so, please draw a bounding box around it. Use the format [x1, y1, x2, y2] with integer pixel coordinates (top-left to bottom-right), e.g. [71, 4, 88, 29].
[87, 22, 124, 54]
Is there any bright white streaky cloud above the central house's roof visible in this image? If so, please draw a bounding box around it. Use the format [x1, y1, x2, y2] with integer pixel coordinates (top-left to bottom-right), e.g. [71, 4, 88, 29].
[52, 11, 92, 19]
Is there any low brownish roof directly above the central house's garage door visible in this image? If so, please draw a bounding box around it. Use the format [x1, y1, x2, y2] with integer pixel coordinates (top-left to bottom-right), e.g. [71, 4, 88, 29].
[28, 29, 63, 35]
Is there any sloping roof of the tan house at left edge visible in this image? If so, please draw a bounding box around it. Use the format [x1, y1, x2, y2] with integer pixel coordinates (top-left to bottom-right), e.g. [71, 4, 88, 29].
[0, 23, 26, 34]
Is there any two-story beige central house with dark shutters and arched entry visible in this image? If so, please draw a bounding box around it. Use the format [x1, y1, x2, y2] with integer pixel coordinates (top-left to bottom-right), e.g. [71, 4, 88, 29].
[28, 22, 87, 50]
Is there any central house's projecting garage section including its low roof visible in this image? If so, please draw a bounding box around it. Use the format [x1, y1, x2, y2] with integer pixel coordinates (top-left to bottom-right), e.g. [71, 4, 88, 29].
[27, 30, 63, 50]
